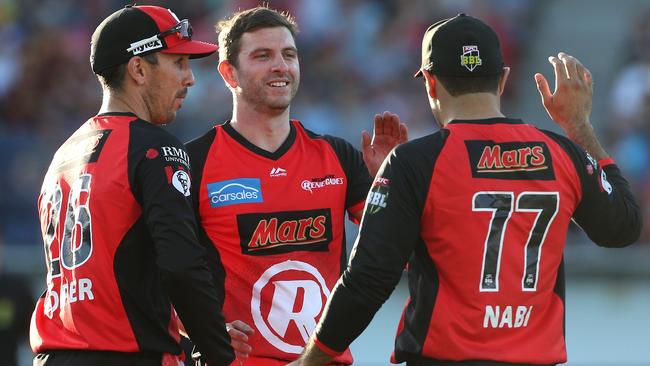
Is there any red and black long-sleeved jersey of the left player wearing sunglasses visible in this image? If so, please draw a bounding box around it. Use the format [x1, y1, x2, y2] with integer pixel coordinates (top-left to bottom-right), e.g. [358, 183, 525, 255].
[31, 113, 234, 364]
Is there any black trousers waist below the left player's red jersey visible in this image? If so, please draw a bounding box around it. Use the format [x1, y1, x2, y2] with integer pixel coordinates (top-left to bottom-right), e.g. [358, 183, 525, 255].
[33, 351, 162, 366]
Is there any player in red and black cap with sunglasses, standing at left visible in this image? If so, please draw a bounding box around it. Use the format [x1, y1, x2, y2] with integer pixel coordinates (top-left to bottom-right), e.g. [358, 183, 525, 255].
[30, 6, 234, 366]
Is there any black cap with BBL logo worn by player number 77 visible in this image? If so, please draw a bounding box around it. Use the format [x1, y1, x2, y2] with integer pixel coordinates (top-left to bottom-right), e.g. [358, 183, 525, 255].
[414, 14, 503, 78]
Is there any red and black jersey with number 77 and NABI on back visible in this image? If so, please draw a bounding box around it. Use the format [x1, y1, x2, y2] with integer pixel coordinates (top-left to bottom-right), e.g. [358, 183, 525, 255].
[317, 118, 640, 365]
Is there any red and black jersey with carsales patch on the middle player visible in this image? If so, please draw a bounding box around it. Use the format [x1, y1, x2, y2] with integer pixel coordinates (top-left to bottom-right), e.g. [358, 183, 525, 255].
[187, 121, 372, 366]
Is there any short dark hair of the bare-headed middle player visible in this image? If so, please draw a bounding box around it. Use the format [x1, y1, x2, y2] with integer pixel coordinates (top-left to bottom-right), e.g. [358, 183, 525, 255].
[216, 6, 298, 66]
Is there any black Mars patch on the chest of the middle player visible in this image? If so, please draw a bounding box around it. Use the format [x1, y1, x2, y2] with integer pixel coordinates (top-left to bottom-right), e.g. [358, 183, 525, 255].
[237, 208, 332, 255]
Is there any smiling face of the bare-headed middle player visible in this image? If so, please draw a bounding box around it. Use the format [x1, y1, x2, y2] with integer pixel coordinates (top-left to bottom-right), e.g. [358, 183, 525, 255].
[228, 27, 300, 114]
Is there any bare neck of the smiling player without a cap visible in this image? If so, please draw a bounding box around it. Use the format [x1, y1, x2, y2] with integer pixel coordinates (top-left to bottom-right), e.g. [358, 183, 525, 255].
[230, 100, 290, 152]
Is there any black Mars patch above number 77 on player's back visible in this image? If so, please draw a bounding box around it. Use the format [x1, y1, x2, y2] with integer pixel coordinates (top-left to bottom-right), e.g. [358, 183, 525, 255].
[465, 140, 555, 180]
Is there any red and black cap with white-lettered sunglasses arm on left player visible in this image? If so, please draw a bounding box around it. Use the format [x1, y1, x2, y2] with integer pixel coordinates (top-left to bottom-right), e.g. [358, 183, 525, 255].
[90, 6, 218, 74]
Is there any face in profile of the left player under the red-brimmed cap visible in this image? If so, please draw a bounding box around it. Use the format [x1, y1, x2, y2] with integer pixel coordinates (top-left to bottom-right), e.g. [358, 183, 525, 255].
[142, 53, 194, 125]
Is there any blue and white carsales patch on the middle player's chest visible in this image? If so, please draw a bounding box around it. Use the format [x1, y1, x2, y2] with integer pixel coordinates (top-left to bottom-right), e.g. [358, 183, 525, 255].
[208, 178, 264, 208]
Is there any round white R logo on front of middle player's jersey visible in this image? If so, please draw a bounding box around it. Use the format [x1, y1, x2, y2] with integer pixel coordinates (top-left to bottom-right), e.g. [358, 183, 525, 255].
[251, 260, 330, 354]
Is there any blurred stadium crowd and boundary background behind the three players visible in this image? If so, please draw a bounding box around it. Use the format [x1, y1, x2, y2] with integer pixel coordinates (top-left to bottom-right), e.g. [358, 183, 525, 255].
[0, 0, 650, 366]
